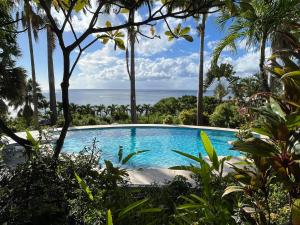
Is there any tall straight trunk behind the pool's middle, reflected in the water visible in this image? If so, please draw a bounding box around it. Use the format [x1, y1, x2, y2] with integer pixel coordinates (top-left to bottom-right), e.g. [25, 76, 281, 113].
[129, 11, 137, 123]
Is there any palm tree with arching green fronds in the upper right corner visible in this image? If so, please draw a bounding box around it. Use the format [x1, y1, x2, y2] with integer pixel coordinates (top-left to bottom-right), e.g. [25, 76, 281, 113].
[213, 0, 299, 92]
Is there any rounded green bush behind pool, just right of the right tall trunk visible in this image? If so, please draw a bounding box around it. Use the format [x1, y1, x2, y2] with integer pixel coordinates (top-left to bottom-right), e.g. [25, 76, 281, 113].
[209, 102, 241, 128]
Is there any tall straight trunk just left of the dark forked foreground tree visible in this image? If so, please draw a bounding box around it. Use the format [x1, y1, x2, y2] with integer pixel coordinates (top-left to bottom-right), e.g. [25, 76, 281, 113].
[47, 26, 57, 125]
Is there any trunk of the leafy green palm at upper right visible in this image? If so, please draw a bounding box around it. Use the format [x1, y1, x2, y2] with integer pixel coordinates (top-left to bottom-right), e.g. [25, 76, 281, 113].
[259, 34, 270, 92]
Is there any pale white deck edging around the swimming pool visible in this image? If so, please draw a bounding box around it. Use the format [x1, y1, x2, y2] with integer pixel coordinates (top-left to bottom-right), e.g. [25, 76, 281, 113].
[2, 124, 241, 185]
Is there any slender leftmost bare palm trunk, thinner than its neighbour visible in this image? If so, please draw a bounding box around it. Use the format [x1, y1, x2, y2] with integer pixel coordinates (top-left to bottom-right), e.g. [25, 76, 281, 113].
[27, 19, 39, 129]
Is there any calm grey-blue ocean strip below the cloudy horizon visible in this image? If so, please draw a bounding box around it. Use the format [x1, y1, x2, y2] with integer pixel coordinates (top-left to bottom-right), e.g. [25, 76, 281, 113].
[43, 89, 213, 105]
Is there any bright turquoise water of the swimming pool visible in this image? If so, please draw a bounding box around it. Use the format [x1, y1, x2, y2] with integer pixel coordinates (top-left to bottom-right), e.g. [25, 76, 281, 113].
[63, 127, 239, 168]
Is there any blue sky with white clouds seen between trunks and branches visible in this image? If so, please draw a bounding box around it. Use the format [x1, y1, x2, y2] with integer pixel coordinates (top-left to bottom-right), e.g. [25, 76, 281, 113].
[18, 1, 268, 90]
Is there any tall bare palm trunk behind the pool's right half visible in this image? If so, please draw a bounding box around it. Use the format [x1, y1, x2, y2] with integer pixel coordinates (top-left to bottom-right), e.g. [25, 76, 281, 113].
[197, 14, 206, 126]
